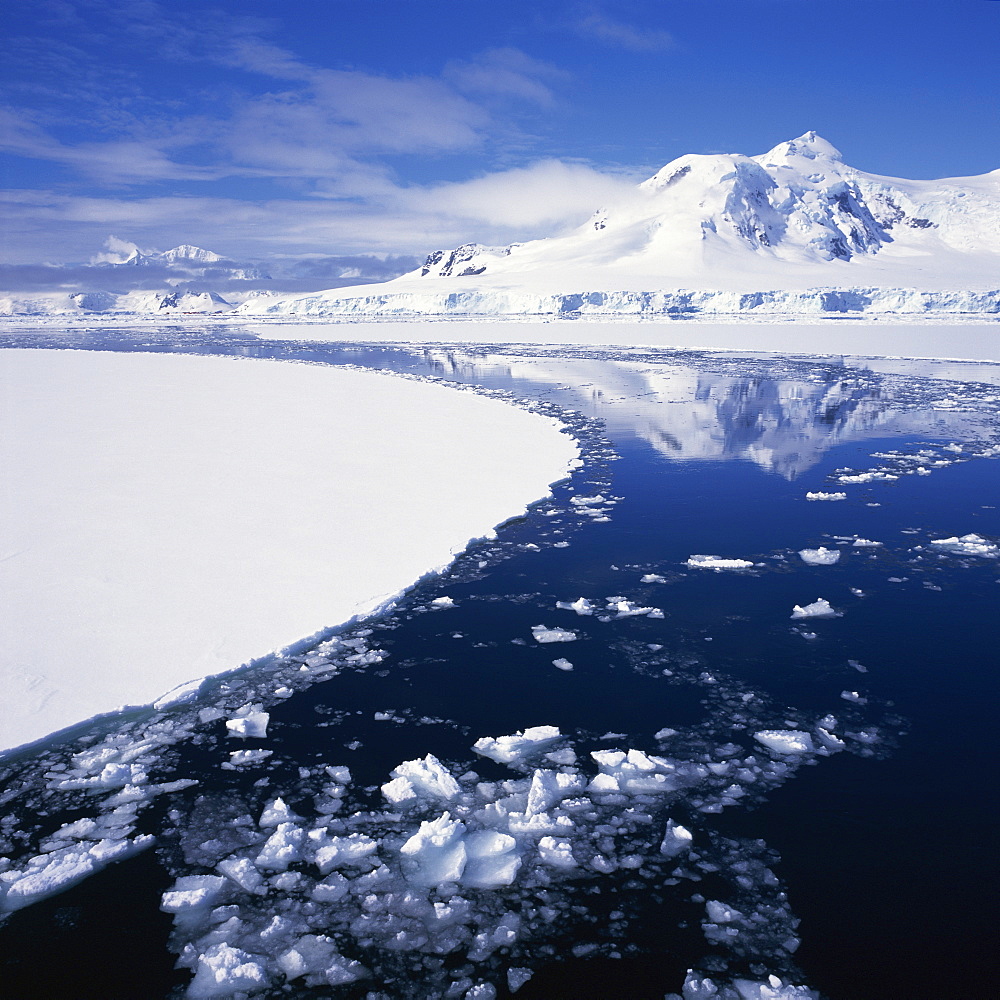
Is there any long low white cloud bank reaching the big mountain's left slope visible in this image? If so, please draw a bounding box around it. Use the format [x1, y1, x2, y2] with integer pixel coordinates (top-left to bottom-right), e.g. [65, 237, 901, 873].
[0, 160, 631, 263]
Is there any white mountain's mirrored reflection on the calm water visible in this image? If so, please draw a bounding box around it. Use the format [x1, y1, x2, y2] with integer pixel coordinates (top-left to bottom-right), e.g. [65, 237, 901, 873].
[423, 350, 992, 480]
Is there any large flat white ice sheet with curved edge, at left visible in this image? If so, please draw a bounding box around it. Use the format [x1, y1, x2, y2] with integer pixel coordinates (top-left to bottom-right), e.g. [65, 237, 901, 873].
[0, 350, 577, 748]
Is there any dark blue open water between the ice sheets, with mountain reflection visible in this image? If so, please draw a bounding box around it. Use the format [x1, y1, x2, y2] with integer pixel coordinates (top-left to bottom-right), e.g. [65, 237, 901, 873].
[0, 333, 1000, 1000]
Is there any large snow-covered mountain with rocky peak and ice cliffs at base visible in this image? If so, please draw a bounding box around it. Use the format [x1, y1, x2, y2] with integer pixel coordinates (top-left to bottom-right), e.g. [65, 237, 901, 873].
[241, 132, 1000, 316]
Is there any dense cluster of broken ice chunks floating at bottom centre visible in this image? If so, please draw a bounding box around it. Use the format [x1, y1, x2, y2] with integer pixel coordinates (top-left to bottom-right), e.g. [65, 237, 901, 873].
[162, 704, 874, 1000]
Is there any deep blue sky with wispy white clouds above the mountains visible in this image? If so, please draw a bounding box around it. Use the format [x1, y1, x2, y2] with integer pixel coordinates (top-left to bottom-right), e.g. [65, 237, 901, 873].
[0, 0, 1000, 274]
